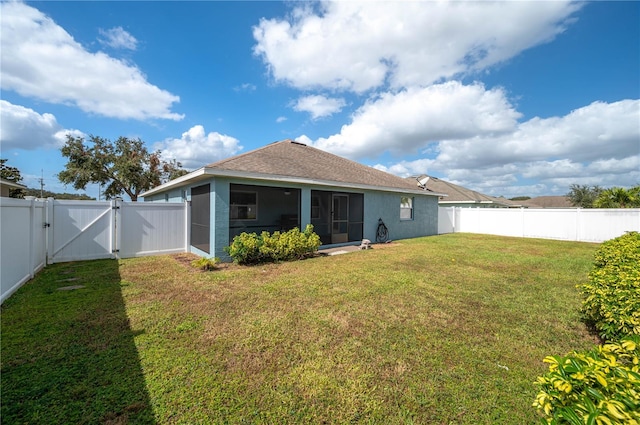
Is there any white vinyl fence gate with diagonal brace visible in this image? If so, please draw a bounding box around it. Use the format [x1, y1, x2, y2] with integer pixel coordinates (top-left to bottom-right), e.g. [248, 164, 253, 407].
[47, 201, 119, 263]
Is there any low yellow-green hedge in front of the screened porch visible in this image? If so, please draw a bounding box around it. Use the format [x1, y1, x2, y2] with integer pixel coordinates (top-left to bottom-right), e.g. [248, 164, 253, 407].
[225, 224, 320, 264]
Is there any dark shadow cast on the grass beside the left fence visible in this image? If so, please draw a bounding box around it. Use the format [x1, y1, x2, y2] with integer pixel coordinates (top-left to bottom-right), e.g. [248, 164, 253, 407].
[0, 260, 156, 424]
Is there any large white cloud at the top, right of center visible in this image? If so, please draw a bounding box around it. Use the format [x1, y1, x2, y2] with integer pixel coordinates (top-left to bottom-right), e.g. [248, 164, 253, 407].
[253, 1, 581, 92]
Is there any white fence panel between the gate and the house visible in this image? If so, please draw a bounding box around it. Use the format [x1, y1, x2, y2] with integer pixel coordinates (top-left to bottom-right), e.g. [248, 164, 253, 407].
[116, 202, 189, 258]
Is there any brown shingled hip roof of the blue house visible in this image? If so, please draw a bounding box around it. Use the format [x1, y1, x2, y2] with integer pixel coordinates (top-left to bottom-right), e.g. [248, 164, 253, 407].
[141, 140, 441, 197]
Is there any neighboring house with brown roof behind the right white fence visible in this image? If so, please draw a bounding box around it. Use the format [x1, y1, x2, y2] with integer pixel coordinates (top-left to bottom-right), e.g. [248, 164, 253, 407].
[407, 175, 521, 208]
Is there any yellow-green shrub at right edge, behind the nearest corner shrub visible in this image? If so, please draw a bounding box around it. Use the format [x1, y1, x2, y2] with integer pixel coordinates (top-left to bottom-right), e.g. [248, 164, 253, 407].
[578, 232, 640, 341]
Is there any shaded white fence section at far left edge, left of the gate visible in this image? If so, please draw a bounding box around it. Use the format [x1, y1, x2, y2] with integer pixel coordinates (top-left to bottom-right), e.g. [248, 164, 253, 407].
[0, 198, 46, 303]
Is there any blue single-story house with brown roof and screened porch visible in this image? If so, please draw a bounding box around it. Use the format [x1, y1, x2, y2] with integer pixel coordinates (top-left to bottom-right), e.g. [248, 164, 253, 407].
[141, 140, 441, 259]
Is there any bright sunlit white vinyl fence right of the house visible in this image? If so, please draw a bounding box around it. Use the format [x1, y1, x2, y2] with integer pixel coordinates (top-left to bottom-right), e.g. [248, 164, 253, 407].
[438, 207, 640, 242]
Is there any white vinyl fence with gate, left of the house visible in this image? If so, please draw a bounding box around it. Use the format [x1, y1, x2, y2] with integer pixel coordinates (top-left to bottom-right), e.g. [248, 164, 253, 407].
[0, 198, 190, 302]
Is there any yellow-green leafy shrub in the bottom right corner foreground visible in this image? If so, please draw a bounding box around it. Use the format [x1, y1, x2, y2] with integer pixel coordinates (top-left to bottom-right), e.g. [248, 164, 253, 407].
[533, 335, 640, 425]
